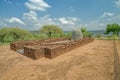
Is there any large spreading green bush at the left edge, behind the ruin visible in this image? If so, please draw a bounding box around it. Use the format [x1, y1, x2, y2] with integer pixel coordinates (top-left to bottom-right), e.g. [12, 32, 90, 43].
[0, 27, 34, 42]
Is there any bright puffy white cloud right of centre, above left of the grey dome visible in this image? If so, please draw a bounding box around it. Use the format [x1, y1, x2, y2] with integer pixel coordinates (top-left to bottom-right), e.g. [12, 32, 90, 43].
[59, 17, 78, 25]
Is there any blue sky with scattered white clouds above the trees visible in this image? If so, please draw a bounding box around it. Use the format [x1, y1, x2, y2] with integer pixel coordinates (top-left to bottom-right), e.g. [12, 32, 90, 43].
[0, 0, 120, 31]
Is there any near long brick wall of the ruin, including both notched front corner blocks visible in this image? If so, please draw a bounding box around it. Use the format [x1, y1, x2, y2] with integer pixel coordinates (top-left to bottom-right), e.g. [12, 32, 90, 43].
[24, 38, 93, 59]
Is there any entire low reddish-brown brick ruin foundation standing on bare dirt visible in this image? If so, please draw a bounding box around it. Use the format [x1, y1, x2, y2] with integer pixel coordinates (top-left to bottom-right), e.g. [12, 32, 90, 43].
[10, 38, 93, 59]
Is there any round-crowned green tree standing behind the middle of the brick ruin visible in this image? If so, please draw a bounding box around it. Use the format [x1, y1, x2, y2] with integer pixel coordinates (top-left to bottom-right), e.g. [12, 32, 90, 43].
[40, 25, 63, 38]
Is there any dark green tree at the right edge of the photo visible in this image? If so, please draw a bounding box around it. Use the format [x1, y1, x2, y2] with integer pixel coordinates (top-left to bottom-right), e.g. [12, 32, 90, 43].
[105, 23, 120, 36]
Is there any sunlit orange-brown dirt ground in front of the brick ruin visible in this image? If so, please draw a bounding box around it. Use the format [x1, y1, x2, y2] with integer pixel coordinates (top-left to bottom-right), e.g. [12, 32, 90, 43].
[0, 40, 120, 80]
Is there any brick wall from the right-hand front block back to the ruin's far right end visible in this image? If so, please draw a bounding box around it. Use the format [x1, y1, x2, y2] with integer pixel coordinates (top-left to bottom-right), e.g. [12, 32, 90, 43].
[45, 38, 93, 59]
